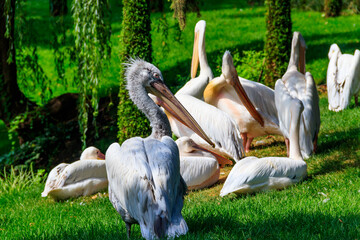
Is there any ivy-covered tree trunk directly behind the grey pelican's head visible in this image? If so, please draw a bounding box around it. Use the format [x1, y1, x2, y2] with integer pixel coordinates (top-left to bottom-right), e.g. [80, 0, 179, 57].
[118, 0, 152, 143]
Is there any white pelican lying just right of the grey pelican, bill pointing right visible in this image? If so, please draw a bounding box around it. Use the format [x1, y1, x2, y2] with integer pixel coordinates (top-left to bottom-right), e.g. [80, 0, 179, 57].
[176, 137, 233, 190]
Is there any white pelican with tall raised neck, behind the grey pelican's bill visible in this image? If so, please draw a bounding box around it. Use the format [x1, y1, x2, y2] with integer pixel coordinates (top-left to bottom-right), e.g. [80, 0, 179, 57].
[164, 20, 243, 161]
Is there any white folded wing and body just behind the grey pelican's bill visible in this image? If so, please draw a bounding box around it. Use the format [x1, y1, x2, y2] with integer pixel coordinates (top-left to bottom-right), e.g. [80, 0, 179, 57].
[170, 94, 244, 161]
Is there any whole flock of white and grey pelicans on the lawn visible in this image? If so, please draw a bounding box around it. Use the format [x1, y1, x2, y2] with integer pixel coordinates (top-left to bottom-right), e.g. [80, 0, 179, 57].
[42, 20, 360, 239]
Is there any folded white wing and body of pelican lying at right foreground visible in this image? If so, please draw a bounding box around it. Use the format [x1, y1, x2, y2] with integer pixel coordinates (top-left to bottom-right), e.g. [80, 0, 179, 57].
[220, 157, 307, 197]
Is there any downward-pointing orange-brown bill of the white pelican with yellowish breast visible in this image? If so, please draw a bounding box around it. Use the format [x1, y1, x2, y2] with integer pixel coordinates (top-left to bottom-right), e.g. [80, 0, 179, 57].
[231, 65, 264, 127]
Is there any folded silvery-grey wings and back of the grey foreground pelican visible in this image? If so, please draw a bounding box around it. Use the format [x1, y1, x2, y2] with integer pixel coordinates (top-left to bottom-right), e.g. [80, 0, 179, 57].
[106, 137, 187, 239]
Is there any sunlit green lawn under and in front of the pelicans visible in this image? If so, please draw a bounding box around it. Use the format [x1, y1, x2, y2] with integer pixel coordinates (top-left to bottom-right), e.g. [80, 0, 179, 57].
[0, 96, 360, 239]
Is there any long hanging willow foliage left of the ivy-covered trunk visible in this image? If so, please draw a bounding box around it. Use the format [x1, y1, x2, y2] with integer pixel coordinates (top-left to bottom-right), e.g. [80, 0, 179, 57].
[73, 0, 111, 148]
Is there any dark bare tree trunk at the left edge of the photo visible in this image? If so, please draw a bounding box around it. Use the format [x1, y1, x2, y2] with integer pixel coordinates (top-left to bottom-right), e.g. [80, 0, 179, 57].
[0, 0, 28, 125]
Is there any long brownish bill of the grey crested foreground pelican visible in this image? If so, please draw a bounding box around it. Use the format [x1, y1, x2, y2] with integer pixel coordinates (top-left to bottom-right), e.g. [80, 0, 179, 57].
[149, 81, 215, 147]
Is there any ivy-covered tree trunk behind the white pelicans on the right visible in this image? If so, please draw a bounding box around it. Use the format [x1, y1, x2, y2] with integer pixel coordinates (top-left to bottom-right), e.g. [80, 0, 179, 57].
[265, 0, 292, 87]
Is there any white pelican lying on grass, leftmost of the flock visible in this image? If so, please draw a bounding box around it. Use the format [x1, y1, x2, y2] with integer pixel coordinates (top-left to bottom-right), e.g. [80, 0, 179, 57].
[41, 147, 108, 201]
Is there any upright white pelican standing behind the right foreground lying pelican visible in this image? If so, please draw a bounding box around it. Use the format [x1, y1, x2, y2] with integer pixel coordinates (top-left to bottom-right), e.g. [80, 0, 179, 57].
[275, 32, 320, 158]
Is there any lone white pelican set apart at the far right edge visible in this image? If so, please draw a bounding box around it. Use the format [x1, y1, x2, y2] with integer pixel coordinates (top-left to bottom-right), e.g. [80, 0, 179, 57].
[326, 43, 360, 112]
